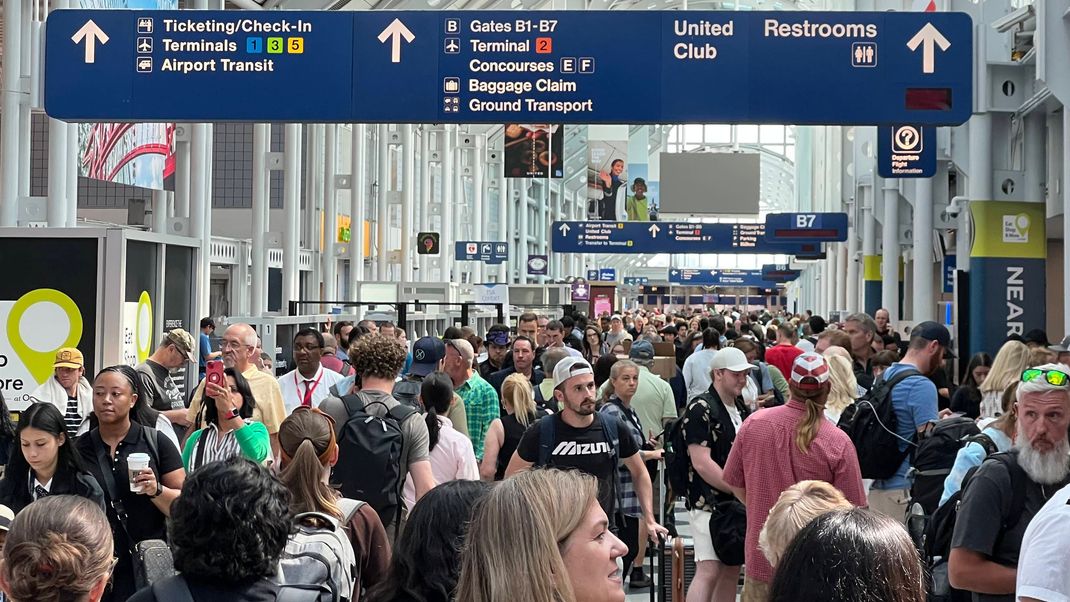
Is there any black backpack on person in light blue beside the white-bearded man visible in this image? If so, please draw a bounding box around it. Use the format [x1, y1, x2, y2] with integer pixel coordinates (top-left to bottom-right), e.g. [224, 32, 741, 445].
[910, 416, 996, 515]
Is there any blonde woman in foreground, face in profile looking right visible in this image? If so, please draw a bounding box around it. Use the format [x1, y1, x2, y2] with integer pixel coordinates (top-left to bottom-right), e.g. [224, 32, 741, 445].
[456, 468, 628, 602]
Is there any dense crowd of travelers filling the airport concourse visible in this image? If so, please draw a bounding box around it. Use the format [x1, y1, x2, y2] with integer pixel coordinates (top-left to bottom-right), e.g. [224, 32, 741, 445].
[0, 308, 1070, 602]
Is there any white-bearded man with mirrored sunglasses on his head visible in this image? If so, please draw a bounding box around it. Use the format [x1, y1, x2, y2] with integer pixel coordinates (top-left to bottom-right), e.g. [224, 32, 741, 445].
[948, 364, 1070, 602]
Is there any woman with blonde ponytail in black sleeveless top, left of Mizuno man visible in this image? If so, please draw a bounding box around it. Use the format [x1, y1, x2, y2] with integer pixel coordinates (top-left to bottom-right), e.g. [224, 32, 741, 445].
[479, 374, 545, 481]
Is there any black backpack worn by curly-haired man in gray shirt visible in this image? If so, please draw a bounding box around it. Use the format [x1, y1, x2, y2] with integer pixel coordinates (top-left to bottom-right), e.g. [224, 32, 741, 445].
[331, 393, 416, 534]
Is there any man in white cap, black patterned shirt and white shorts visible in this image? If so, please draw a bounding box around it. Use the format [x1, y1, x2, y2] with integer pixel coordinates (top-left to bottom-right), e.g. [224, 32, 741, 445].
[683, 348, 753, 602]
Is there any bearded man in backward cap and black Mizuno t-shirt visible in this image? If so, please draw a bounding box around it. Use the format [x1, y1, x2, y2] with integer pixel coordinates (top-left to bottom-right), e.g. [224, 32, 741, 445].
[505, 357, 669, 540]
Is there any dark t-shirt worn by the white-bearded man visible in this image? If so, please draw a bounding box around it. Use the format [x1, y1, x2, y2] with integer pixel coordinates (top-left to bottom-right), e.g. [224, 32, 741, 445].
[951, 450, 1067, 602]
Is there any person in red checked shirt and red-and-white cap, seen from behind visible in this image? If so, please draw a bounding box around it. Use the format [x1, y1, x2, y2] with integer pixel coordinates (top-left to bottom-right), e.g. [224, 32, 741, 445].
[724, 353, 866, 602]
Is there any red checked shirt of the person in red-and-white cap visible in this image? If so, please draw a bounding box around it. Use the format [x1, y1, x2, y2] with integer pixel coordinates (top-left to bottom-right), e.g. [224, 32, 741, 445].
[724, 399, 866, 583]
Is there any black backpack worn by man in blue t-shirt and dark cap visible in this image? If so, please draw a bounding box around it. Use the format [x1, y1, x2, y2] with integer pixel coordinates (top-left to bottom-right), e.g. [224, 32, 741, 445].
[839, 368, 922, 479]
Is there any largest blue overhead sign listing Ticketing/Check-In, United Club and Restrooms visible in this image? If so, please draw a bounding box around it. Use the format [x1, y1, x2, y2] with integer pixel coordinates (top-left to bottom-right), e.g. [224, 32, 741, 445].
[45, 10, 973, 125]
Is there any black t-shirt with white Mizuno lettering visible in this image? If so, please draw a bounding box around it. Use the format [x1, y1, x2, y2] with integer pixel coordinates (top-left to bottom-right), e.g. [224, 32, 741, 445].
[517, 414, 639, 516]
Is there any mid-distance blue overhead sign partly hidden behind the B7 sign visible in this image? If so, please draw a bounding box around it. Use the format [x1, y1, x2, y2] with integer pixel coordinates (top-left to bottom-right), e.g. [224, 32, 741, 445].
[550, 221, 821, 254]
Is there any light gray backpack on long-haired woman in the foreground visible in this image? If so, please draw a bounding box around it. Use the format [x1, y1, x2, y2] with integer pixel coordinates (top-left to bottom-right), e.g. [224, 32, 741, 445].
[278, 498, 364, 602]
